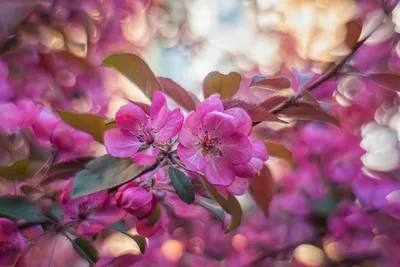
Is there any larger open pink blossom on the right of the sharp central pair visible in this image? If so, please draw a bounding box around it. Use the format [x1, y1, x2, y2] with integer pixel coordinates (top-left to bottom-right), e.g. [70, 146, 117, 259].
[178, 95, 252, 186]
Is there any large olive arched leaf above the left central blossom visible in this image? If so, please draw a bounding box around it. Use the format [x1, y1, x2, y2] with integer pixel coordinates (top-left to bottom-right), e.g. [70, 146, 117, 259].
[101, 54, 163, 99]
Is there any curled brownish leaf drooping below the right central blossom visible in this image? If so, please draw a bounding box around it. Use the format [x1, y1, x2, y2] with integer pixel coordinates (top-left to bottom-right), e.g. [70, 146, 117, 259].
[203, 178, 243, 233]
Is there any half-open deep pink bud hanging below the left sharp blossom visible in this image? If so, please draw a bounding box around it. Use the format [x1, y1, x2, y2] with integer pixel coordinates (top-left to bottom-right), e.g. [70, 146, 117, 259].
[115, 182, 157, 220]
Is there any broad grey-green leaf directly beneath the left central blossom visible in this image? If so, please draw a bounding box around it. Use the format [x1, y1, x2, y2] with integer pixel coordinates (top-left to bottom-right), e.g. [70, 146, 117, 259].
[72, 154, 145, 198]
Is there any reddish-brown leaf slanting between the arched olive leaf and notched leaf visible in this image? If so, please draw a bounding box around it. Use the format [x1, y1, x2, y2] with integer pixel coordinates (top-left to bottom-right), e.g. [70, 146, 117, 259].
[157, 77, 196, 111]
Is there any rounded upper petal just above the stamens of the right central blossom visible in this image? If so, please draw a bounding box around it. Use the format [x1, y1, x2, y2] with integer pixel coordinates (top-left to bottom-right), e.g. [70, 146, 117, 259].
[203, 111, 236, 138]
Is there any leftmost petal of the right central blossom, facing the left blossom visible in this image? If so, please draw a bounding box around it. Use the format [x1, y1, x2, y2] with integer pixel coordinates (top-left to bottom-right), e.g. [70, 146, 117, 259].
[179, 111, 201, 147]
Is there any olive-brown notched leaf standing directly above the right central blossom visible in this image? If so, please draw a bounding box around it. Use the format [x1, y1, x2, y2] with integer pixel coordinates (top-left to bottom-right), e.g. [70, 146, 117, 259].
[203, 71, 242, 99]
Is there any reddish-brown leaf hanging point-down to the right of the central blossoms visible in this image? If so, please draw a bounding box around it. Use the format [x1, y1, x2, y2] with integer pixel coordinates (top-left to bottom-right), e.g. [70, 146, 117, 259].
[249, 165, 274, 216]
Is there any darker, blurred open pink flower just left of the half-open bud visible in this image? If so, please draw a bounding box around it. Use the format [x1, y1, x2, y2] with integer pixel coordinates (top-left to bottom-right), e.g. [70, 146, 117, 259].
[60, 179, 126, 236]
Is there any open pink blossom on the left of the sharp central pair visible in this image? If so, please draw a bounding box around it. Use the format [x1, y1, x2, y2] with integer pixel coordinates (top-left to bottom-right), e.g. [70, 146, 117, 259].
[104, 92, 183, 165]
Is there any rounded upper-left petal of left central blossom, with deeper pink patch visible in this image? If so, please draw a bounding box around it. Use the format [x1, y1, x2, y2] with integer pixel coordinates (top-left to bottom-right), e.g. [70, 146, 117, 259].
[115, 103, 147, 134]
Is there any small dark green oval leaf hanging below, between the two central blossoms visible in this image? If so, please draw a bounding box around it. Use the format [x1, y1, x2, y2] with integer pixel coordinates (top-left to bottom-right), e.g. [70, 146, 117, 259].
[168, 167, 194, 204]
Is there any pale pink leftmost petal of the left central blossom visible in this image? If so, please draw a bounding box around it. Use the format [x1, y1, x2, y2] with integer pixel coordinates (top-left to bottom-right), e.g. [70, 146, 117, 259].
[104, 128, 142, 158]
